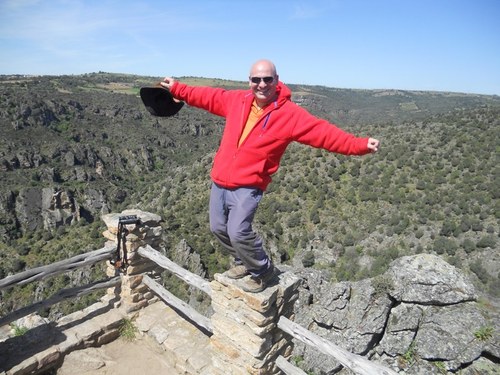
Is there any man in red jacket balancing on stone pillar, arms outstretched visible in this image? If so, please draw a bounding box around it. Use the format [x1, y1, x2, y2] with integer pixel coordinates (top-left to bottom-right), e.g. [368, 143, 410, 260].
[161, 60, 379, 293]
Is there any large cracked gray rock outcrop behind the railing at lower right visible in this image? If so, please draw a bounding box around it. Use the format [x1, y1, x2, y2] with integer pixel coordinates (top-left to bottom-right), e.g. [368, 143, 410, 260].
[295, 254, 500, 374]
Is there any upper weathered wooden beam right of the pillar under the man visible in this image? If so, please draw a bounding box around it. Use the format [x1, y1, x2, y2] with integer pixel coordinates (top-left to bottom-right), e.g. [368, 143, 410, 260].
[278, 316, 397, 375]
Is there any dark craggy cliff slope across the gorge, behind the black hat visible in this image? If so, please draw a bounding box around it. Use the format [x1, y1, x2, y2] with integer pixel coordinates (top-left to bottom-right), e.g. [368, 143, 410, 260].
[0, 73, 223, 240]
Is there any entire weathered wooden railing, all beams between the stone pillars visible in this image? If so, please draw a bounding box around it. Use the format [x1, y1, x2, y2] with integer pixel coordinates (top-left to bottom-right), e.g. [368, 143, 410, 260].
[0, 245, 396, 375]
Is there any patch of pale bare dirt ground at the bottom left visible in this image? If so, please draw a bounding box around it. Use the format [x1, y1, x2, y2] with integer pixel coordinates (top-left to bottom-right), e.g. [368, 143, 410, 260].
[56, 335, 179, 375]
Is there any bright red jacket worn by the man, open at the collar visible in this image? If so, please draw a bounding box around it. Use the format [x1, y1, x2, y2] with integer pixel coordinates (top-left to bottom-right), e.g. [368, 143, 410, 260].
[171, 82, 370, 190]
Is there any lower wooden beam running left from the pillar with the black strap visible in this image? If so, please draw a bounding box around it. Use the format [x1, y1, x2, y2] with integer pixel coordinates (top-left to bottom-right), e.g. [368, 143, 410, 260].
[0, 276, 121, 327]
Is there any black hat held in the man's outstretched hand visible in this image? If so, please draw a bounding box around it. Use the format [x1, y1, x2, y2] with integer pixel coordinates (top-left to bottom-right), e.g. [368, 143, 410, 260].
[140, 84, 184, 117]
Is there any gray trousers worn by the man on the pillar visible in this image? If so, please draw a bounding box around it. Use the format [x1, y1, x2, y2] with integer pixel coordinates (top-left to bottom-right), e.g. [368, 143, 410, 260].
[210, 183, 271, 276]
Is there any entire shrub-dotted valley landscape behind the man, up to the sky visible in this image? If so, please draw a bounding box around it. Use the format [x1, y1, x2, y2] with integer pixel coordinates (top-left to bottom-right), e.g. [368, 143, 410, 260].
[0, 73, 500, 315]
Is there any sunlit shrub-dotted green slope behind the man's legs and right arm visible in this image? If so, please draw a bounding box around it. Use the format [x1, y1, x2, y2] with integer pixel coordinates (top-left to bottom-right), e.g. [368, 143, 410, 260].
[136, 108, 500, 294]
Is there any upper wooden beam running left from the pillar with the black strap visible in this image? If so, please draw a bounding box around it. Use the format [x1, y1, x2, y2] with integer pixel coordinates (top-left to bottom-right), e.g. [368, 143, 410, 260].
[0, 247, 116, 290]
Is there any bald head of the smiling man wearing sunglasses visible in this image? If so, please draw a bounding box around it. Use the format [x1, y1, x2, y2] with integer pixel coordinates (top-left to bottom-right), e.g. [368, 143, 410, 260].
[248, 60, 279, 107]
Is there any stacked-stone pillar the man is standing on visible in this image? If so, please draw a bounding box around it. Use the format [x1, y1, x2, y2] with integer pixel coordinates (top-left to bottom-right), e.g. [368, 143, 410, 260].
[210, 273, 300, 375]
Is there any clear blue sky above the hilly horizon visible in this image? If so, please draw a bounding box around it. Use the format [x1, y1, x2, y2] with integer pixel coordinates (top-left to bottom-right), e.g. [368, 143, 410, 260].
[0, 0, 500, 95]
